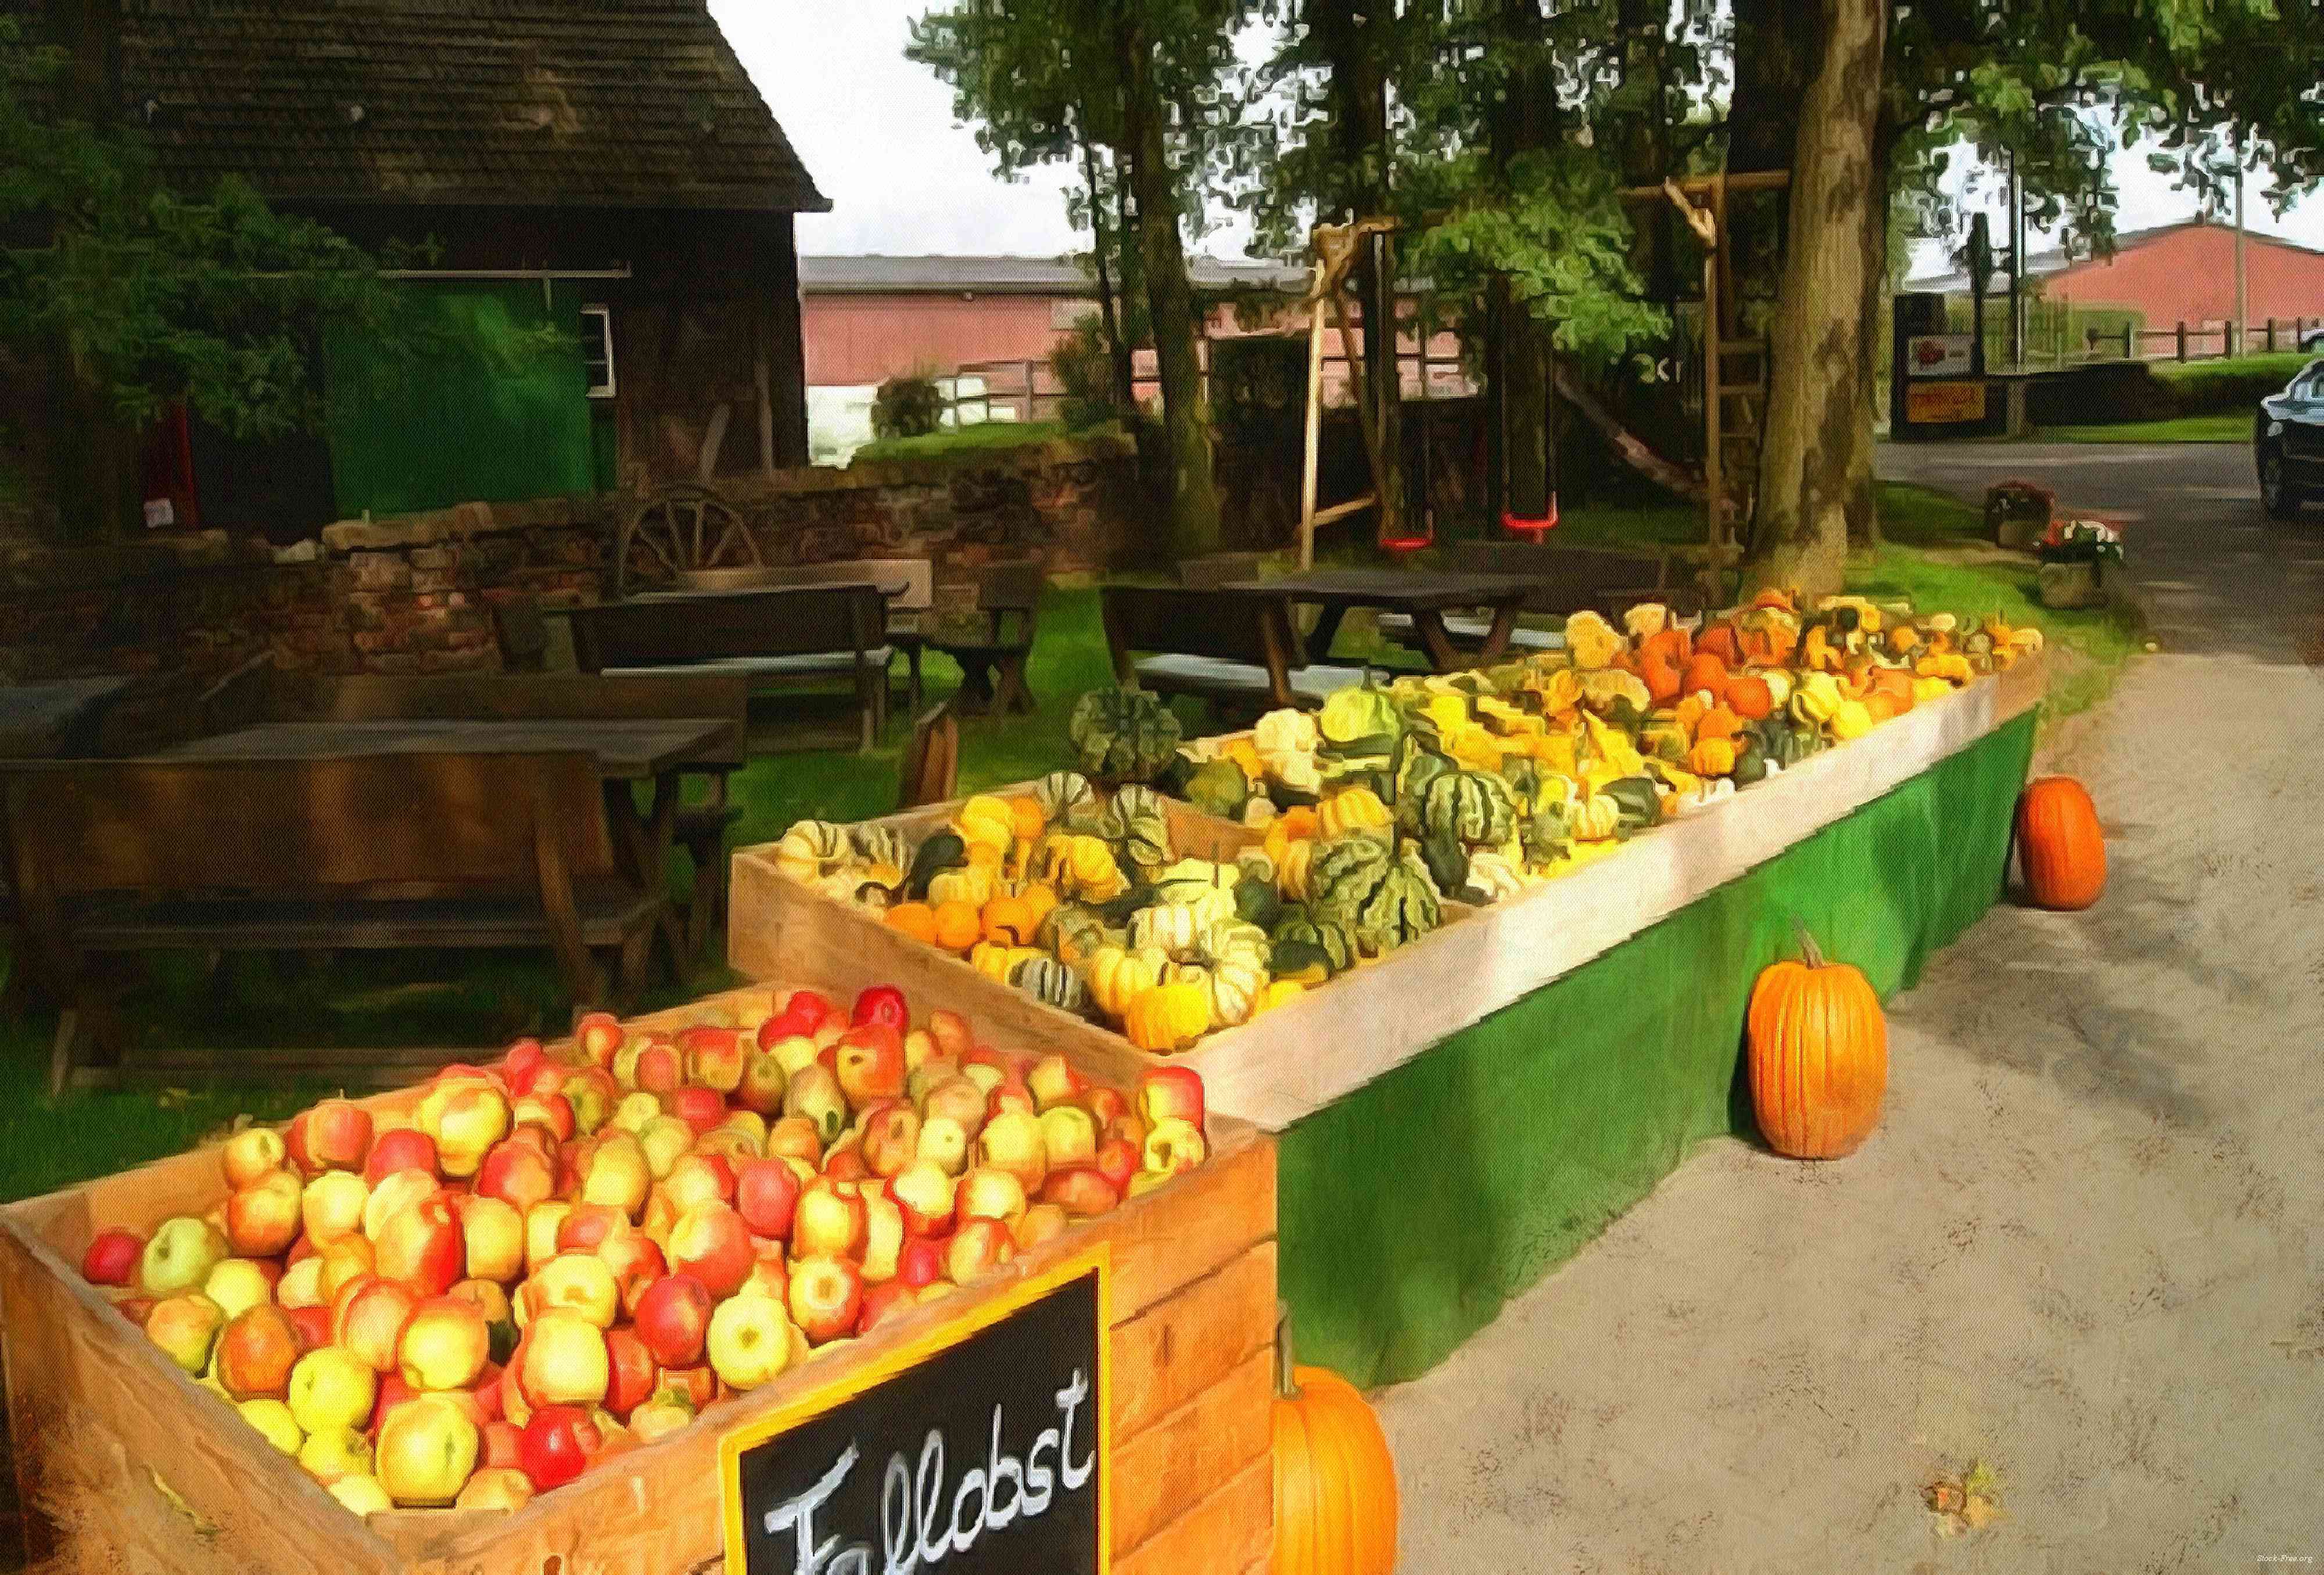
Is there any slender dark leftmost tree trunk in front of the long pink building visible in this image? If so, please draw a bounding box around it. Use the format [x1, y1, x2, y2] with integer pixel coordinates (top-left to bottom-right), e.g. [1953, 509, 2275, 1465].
[1122, 26, 1220, 557]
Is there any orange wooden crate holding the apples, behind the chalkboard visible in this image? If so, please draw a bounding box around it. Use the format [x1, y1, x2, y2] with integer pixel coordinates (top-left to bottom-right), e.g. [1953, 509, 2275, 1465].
[0, 980, 1276, 1575]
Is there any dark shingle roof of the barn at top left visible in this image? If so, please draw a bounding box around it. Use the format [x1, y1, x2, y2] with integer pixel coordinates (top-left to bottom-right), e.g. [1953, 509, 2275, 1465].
[0, 0, 830, 212]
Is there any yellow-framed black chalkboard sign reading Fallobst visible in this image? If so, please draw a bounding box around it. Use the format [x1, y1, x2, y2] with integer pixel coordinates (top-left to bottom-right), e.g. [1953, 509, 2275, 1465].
[718, 1243, 1111, 1575]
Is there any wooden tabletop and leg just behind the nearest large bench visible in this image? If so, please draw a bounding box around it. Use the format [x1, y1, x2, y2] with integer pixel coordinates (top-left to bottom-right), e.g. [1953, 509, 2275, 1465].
[160, 718, 744, 978]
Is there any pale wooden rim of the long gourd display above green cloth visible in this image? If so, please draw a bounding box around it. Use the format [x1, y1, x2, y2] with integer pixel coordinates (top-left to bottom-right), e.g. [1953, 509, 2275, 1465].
[727, 655, 2047, 1132]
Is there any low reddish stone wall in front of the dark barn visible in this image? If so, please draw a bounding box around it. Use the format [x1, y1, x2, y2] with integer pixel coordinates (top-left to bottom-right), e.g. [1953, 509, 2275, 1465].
[0, 439, 1164, 743]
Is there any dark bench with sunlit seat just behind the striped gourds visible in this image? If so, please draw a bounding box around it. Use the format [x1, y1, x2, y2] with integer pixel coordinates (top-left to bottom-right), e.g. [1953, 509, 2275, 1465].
[1104, 585, 1364, 708]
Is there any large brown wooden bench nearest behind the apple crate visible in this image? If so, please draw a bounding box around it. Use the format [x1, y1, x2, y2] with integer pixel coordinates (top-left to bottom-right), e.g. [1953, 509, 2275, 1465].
[0, 755, 665, 1087]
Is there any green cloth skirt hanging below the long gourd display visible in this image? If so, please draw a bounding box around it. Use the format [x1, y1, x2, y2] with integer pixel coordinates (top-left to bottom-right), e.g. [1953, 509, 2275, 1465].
[1281, 715, 2033, 1387]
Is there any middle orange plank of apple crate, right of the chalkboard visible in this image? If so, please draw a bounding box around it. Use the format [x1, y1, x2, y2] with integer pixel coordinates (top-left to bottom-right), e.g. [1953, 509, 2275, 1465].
[1113, 1240, 1276, 1440]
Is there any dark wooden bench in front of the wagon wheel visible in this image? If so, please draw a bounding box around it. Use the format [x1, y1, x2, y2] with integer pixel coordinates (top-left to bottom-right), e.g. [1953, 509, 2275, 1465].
[567, 585, 895, 750]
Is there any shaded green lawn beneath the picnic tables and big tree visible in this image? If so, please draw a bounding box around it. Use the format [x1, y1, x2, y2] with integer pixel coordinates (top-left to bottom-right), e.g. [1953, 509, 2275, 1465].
[0, 488, 2138, 1198]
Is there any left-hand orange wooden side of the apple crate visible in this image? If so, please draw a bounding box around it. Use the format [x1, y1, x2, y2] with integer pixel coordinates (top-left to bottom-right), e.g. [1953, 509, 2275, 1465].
[0, 1224, 395, 1575]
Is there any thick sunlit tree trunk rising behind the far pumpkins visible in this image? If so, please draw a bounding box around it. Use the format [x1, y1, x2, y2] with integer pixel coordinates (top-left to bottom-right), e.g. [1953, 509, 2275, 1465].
[1743, 0, 1887, 597]
